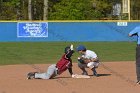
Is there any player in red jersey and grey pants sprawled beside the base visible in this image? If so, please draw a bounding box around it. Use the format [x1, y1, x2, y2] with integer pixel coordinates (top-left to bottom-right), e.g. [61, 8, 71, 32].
[27, 45, 74, 79]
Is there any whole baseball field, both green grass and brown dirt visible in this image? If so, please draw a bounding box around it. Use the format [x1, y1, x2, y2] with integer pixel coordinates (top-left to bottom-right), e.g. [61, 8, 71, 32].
[0, 42, 140, 93]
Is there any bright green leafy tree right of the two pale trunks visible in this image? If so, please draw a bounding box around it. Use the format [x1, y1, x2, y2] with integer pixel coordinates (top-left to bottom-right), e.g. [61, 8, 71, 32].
[49, 0, 111, 20]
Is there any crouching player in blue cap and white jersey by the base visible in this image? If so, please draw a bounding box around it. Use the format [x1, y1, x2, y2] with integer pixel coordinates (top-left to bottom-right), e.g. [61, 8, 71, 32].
[76, 45, 99, 76]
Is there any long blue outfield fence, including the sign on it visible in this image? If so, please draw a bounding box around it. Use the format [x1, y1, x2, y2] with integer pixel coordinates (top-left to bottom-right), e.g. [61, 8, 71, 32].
[0, 21, 140, 42]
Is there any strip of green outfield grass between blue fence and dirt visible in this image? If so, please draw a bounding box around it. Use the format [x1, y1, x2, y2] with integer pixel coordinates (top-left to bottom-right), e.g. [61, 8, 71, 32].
[0, 42, 136, 65]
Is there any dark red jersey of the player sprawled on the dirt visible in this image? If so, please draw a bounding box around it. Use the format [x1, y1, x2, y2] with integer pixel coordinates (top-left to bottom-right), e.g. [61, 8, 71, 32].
[56, 54, 72, 75]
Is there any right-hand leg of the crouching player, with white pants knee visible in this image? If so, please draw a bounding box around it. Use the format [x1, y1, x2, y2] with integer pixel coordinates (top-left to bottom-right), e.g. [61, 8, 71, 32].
[87, 62, 99, 76]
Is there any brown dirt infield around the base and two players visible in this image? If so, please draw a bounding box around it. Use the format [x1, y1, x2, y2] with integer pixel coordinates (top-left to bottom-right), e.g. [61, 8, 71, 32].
[0, 62, 140, 93]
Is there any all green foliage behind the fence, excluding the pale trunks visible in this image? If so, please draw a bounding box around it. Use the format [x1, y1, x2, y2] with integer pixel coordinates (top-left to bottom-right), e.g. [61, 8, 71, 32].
[0, 0, 140, 20]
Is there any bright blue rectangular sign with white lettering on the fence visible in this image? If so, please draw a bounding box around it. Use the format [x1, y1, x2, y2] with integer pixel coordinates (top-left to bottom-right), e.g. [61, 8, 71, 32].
[17, 22, 48, 37]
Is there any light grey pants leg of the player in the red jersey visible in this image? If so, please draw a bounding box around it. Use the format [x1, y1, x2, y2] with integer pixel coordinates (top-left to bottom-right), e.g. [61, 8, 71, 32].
[35, 64, 57, 79]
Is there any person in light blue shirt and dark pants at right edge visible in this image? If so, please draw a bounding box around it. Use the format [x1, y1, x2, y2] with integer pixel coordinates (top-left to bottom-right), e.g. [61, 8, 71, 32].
[129, 26, 140, 84]
